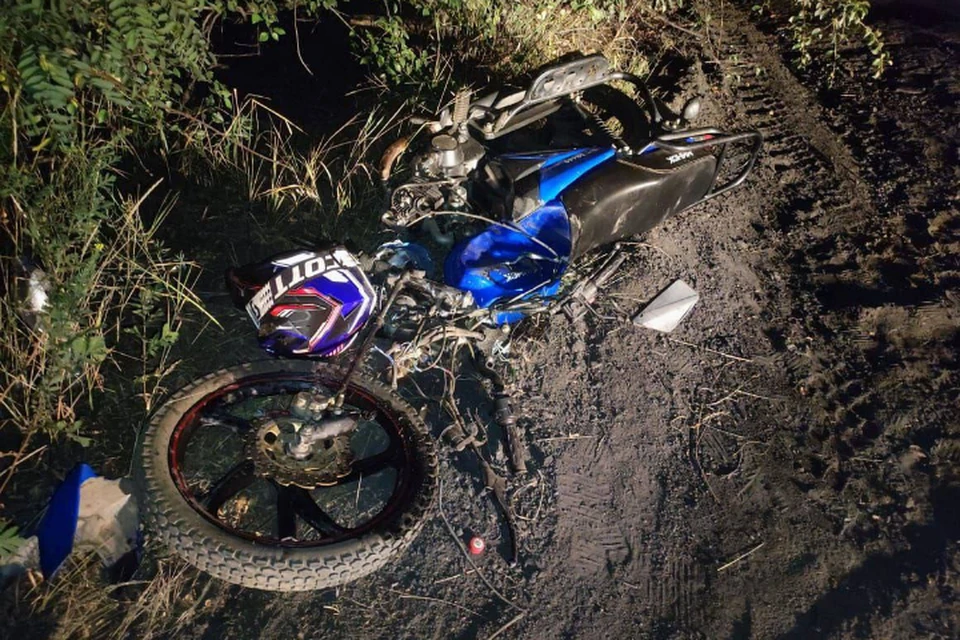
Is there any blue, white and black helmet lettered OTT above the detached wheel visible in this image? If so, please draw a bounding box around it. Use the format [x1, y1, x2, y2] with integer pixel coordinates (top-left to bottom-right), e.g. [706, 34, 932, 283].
[226, 247, 377, 357]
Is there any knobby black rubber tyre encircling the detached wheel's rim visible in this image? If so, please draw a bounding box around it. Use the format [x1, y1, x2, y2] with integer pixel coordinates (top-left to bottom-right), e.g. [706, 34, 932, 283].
[136, 361, 437, 591]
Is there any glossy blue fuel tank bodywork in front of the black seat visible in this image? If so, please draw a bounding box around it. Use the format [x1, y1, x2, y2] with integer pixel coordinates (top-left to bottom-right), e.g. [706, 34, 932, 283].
[444, 147, 615, 324]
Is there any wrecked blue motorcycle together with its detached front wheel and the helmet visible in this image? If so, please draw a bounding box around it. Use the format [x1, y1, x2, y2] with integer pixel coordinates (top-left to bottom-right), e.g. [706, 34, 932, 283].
[138, 55, 762, 591]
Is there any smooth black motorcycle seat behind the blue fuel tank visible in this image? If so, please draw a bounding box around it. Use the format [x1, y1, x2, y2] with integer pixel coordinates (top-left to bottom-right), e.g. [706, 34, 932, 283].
[561, 152, 717, 259]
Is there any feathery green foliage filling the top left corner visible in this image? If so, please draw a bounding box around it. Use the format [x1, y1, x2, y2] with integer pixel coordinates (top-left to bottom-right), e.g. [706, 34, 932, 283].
[0, 0, 214, 151]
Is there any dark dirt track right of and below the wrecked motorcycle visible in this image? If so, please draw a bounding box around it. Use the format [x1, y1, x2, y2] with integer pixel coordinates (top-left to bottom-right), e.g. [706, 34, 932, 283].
[3, 3, 960, 640]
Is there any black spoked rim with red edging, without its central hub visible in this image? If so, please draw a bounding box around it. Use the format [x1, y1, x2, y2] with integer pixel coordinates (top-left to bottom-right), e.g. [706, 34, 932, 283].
[168, 372, 419, 548]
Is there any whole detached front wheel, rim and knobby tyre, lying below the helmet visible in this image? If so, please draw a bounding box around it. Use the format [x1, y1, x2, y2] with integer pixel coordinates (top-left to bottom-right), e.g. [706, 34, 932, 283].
[138, 361, 437, 591]
